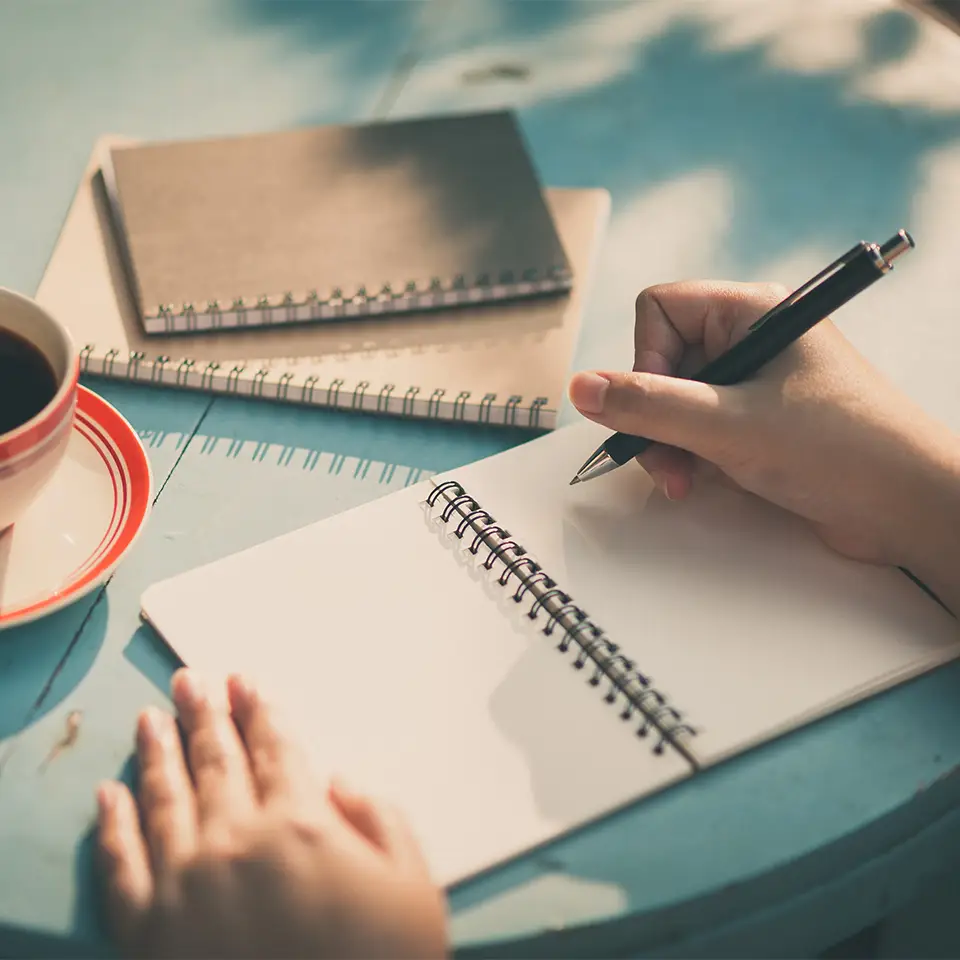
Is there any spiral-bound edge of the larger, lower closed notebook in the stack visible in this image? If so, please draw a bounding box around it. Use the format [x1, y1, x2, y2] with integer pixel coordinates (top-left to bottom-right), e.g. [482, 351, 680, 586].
[80, 343, 557, 430]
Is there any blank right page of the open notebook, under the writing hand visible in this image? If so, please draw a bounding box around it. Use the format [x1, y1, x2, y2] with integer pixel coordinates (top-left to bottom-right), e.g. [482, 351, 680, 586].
[438, 424, 960, 765]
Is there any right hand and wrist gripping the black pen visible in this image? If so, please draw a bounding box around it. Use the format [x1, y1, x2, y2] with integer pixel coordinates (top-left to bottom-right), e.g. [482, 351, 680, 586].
[570, 229, 960, 615]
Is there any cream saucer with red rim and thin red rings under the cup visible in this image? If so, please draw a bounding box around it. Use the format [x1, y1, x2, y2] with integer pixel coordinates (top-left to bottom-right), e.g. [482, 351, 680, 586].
[0, 387, 153, 630]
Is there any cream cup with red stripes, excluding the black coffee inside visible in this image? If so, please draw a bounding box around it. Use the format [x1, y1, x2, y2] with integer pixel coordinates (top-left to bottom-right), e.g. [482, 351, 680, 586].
[0, 287, 80, 532]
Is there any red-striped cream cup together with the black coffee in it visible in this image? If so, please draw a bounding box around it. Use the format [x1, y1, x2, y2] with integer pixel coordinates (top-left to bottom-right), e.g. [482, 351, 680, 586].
[0, 287, 80, 533]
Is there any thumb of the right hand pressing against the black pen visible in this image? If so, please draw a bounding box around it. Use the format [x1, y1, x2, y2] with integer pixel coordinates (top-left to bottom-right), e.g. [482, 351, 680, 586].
[570, 372, 742, 460]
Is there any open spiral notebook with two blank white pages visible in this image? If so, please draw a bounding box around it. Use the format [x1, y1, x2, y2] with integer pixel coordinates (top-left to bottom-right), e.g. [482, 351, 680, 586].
[142, 424, 960, 885]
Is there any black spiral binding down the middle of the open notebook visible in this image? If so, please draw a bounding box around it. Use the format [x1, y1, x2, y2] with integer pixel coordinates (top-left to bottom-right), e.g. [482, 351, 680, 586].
[426, 480, 697, 762]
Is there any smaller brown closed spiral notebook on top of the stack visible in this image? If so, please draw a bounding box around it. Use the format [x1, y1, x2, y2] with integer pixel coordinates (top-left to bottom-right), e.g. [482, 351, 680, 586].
[104, 111, 572, 333]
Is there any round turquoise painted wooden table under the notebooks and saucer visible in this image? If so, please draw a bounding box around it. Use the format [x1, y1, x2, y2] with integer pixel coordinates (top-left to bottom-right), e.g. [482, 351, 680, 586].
[0, 0, 960, 956]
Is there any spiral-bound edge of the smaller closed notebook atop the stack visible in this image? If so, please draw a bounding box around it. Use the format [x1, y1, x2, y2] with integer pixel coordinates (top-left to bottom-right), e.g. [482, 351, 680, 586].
[143, 266, 573, 333]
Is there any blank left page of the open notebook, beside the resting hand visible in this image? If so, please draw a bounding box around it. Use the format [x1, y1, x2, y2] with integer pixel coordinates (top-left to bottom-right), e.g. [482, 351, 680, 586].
[143, 446, 690, 884]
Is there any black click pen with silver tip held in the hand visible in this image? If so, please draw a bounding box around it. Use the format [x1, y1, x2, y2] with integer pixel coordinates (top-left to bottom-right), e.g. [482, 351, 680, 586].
[570, 230, 914, 485]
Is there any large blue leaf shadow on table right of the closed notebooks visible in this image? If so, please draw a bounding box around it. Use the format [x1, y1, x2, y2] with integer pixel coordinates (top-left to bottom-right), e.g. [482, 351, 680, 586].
[522, 5, 960, 270]
